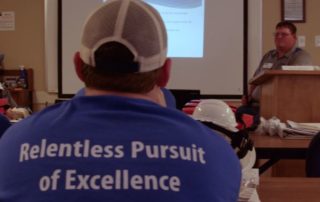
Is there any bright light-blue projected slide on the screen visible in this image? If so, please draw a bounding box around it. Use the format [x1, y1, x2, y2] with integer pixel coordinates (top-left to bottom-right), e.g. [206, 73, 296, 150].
[103, 0, 205, 58]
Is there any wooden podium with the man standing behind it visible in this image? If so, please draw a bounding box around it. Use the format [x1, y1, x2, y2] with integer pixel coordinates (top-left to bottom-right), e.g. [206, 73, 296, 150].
[250, 70, 320, 122]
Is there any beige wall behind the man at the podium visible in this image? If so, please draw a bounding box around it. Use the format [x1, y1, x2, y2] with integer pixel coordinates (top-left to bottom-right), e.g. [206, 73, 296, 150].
[262, 0, 320, 65]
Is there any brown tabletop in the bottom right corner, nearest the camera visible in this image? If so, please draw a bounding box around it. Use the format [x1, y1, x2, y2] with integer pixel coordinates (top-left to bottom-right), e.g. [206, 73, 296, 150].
[257, 177, 320, 202]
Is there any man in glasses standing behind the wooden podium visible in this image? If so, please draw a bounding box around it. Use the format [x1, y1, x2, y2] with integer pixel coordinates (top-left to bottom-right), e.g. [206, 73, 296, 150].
[237, 21, 312, 128]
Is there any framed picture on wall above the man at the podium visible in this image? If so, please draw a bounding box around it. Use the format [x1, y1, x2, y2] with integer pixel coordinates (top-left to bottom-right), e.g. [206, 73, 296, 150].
[281, 0, 306, 23]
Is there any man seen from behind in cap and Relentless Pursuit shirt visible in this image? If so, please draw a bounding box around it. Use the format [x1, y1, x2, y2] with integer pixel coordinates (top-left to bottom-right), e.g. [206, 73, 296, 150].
[0, 0, 241, 202]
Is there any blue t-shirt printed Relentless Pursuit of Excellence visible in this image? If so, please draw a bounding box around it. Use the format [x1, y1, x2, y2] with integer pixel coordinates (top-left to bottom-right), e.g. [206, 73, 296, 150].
[0, 96, 241, 202]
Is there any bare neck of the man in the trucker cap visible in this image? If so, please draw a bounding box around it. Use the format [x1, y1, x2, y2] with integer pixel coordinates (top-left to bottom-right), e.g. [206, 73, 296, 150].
[85, 86, 166, 107]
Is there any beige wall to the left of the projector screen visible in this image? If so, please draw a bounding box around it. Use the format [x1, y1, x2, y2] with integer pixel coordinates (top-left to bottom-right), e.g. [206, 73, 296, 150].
[0, 0, 45, 91]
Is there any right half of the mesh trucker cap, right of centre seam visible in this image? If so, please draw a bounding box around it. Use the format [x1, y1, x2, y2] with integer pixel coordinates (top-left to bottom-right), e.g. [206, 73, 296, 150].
[122, 1, 167, 72]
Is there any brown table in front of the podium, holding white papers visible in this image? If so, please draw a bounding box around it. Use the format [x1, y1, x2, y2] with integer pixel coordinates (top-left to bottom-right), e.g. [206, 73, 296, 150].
[250, 133, 310, 174]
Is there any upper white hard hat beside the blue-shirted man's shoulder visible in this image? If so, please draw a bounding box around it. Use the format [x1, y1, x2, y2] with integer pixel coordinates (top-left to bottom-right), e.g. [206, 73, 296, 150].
[192, 99, 238, 132]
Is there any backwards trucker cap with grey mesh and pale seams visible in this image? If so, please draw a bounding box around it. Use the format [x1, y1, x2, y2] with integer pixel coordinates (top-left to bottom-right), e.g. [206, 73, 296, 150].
[80, 0, 167, 72]
